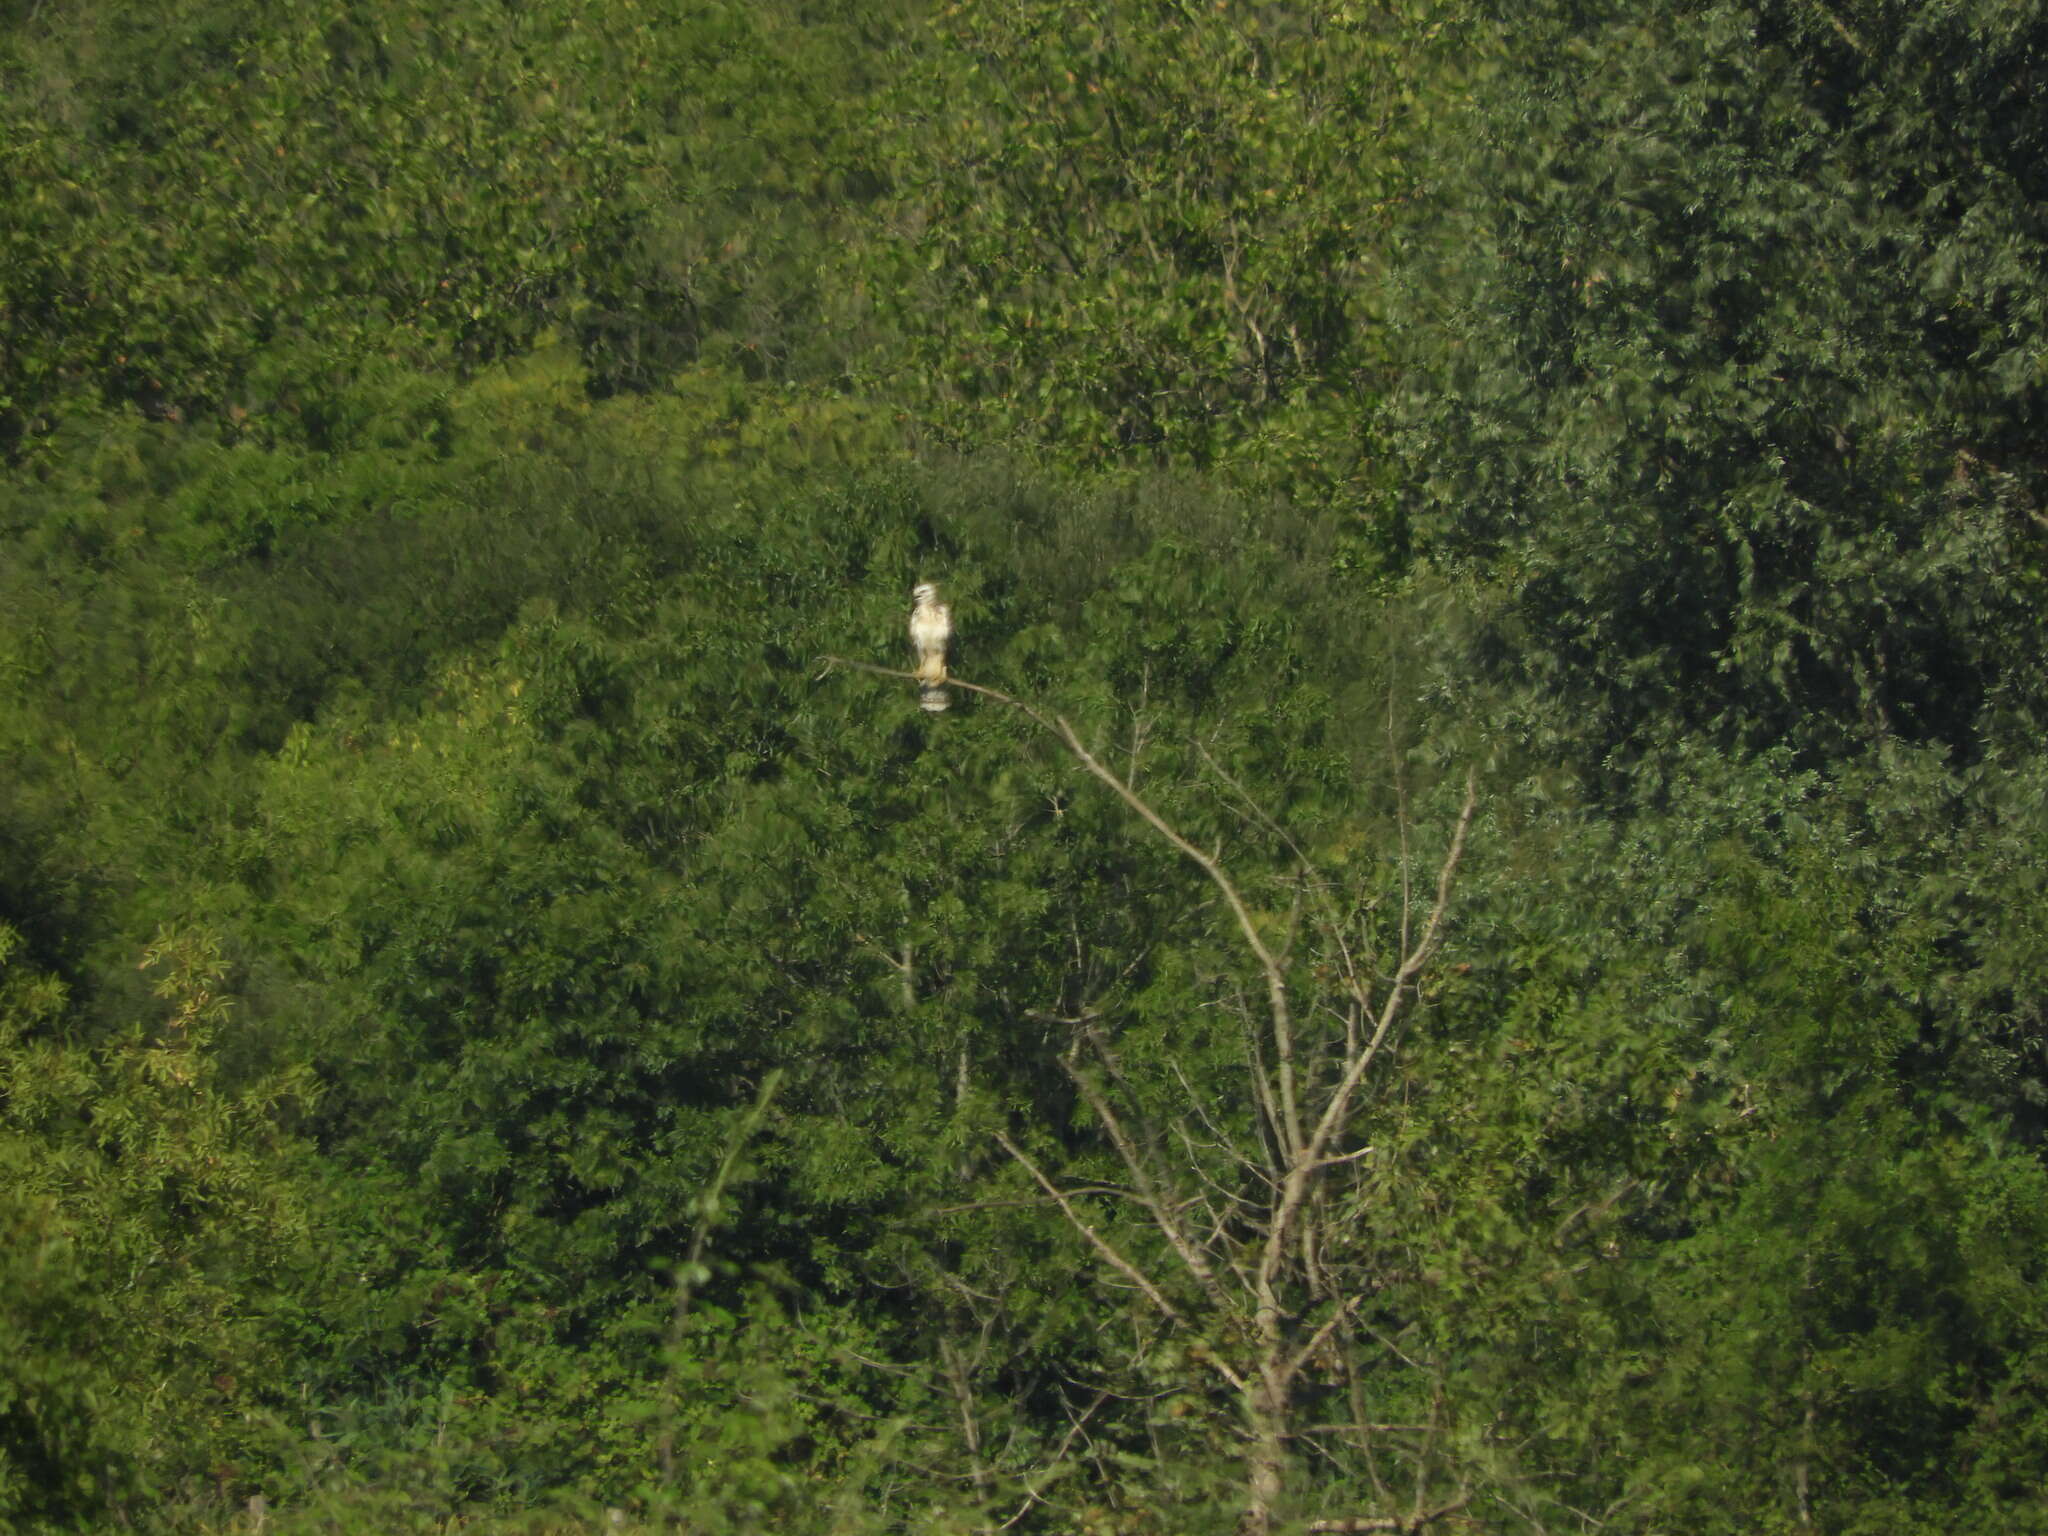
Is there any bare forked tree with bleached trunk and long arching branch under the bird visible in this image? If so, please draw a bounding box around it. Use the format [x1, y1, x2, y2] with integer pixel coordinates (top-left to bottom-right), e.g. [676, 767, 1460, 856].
[825, 657, 1479, 1536]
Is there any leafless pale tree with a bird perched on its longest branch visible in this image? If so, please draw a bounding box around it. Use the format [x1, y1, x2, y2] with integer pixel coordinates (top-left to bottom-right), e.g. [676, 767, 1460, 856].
[827, 657, 1479, 1536]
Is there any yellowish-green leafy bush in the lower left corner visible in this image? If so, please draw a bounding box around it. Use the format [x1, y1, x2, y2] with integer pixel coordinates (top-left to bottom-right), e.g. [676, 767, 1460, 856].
[0, 926, 311, 1530]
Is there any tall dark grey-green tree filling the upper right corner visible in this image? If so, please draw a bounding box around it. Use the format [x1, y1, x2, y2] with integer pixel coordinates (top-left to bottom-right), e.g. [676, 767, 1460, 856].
[1401, 4, 2044, 764]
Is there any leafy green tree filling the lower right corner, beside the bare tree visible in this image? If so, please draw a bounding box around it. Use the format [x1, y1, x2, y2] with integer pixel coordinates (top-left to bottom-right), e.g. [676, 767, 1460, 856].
[1413, 754, 2048, 1530]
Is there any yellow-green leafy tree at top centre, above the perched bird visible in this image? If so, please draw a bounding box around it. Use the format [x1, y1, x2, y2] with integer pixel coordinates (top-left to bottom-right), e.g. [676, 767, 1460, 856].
[866, 0, 1458, 518]
